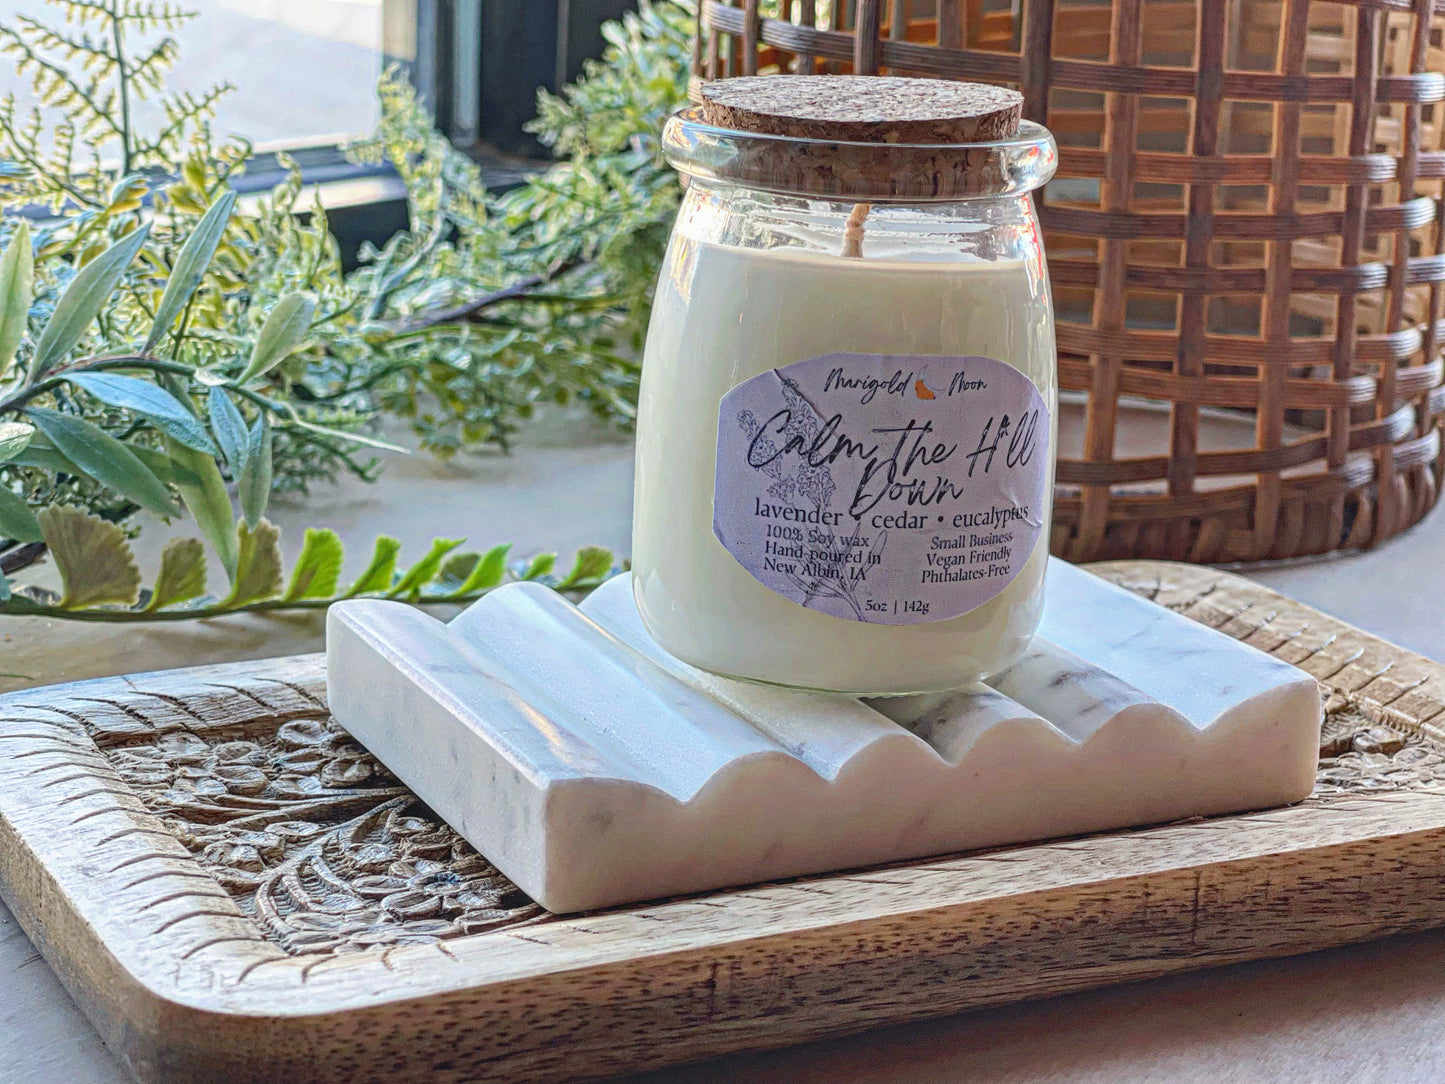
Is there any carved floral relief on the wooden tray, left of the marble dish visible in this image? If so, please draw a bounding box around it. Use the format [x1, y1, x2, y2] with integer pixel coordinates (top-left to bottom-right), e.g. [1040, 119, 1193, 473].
[105, 714, 546, 954]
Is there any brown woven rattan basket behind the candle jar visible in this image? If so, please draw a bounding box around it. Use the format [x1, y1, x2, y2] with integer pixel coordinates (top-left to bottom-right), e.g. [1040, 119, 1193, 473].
[694, 0, 1445, 561]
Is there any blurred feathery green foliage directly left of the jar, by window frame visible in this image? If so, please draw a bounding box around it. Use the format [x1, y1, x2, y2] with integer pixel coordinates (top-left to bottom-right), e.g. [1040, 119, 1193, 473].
[342, 0, 692, 455]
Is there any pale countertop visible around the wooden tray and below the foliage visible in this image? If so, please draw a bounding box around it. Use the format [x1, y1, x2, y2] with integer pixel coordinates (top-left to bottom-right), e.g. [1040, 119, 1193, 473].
[0, 425, 1445, 1084]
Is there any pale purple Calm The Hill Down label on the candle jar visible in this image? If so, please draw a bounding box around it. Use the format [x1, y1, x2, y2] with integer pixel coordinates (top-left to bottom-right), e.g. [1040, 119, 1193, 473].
[712, 354, 1051, 624]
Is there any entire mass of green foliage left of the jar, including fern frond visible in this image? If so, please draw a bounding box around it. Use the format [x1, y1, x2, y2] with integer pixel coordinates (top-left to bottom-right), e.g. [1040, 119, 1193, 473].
[0, 0, 664, 620]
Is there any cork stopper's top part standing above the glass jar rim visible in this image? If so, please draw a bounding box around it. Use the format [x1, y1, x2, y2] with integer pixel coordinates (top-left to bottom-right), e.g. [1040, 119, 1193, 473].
[701, 75, 1023, 143]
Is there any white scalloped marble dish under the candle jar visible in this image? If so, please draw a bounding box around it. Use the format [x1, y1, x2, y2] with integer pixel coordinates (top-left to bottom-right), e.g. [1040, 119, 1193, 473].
[327, 561, 1321, 912]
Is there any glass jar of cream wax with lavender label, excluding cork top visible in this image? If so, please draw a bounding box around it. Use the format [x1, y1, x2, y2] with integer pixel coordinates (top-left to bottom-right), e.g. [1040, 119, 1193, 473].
[633, 77, 1058, 695]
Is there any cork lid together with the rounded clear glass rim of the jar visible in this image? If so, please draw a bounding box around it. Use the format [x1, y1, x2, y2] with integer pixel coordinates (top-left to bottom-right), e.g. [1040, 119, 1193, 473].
[662, 75, 1058, 202]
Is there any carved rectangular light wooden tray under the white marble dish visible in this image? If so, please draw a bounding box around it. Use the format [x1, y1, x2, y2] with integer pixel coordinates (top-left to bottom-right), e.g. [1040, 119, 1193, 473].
[0, 562, 1445, 1084]
